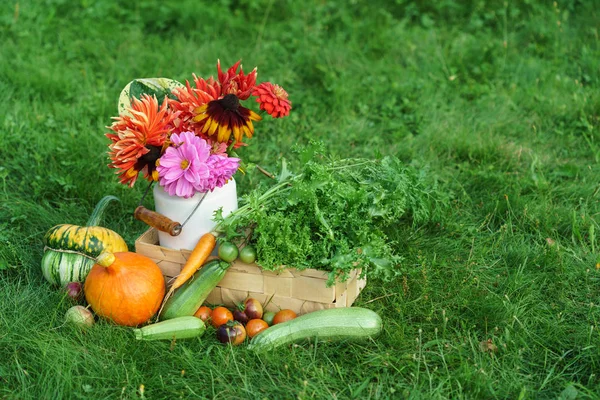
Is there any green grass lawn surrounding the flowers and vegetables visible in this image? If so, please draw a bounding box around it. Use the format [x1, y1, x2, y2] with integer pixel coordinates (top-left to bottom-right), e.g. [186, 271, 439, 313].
[0, 0, 600, 399]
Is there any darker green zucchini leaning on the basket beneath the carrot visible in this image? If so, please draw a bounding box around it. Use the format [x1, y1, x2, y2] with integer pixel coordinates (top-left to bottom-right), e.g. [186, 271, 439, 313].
[159, 260, 230, 320]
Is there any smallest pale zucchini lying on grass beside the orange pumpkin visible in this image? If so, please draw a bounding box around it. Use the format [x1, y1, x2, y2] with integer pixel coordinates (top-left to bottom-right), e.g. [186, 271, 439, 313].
[133, 316, 206, 340]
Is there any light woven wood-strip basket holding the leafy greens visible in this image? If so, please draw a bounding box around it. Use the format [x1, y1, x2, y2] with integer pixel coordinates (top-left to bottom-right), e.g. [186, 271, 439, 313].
[135, 229, 367, 314]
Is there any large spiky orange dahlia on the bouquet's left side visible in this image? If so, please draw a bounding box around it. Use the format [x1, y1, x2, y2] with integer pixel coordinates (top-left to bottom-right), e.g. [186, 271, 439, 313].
[106, 94, 179, 187]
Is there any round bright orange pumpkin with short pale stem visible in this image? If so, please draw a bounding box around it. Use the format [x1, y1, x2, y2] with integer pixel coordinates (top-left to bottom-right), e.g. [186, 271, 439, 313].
[84, 252, 165, 326]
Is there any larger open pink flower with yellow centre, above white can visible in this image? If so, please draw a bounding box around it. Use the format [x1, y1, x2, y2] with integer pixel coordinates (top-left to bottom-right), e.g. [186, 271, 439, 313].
[156, 132, 211, 198]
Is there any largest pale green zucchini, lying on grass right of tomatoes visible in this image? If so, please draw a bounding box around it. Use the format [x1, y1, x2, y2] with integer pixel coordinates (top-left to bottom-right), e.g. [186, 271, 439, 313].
[248, 307, 382, 352]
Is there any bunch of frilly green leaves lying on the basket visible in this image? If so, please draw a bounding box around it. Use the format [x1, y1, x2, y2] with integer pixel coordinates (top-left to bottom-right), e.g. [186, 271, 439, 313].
[216, 148, 441, 284]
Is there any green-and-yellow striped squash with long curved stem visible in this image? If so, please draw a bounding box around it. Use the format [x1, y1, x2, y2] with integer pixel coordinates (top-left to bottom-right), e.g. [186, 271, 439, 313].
[42, 196, 128, 286]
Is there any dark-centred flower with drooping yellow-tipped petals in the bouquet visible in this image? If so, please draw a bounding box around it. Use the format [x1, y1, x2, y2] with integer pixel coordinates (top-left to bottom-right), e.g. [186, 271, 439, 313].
[194, 94, 262, 143]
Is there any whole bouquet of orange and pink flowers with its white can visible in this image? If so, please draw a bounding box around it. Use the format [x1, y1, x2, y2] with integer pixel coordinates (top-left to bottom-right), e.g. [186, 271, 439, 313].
[106, 61, 292, 248]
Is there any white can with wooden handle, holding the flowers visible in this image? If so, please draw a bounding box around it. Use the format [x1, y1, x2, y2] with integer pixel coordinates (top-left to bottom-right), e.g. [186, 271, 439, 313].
[153, 178, 238, 250]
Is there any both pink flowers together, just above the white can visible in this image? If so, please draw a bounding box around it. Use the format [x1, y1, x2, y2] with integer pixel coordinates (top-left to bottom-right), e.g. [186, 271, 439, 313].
[156, 132, 240, 198]
